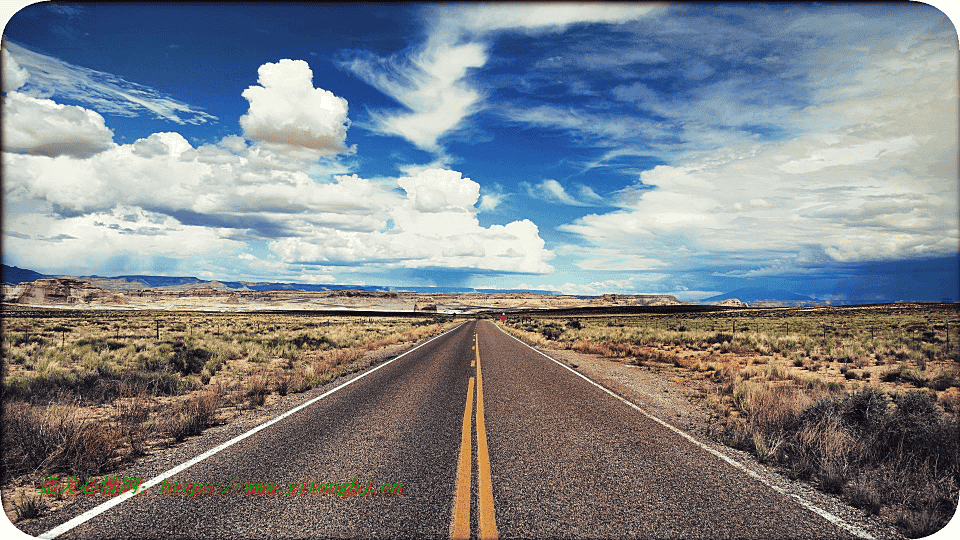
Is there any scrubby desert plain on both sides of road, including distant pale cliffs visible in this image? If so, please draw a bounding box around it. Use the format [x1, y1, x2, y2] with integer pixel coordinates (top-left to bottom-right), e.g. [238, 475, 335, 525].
[2, 279, 960, 537]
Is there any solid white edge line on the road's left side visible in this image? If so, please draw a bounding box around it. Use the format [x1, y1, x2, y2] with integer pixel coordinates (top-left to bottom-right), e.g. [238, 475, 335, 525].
[38, 321, 467, 540]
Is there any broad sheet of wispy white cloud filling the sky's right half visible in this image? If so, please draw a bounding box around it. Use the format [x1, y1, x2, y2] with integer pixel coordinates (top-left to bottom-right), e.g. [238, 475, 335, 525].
[496, 6, 958, 277]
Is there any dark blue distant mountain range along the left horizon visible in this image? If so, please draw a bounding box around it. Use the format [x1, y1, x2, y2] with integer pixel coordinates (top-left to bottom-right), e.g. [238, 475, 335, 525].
[2, 264, 556, 294]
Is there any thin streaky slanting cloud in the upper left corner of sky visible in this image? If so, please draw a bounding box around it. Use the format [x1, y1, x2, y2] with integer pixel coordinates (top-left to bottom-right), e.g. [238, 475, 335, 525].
[5, 41, 217, 125]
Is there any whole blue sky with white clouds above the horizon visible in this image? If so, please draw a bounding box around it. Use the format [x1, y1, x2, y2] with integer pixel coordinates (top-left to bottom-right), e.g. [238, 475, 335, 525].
[2, 3, 960, 303]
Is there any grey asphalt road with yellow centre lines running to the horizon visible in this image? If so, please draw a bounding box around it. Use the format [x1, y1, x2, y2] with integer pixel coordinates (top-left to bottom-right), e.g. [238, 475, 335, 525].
[28, 321, 864, 539]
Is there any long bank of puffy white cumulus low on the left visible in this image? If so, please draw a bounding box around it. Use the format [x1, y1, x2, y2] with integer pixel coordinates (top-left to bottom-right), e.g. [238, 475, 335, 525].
[4, 124, 553, 274]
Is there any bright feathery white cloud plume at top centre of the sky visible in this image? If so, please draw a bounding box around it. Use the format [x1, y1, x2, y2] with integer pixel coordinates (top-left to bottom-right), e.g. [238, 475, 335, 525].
[340, 3, 660, 153]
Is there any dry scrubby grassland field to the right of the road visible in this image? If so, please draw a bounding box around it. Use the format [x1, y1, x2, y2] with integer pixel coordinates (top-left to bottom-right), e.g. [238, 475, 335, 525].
[503, 306, 960, 537]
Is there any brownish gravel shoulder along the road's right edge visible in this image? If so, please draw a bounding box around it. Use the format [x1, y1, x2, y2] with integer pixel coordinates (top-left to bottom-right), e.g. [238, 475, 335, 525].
[538, 349, 903, 539]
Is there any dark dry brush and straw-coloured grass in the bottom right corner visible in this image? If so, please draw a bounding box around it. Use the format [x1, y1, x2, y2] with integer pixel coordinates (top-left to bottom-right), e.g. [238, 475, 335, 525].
[721, 381, 960, 537]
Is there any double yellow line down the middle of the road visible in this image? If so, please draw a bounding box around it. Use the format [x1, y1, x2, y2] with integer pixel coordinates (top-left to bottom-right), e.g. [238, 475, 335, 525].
[450, 334, 498, 539]
